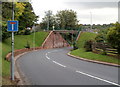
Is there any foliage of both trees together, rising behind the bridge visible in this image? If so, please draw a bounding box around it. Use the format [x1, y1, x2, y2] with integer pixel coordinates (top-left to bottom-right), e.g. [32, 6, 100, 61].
[40, 10, 79, 30]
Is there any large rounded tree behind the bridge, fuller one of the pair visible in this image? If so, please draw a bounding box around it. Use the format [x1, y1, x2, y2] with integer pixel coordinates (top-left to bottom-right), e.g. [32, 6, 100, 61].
[56, 10, 78, 30]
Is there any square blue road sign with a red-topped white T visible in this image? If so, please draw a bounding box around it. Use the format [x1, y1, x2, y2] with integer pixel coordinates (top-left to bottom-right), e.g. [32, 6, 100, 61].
[7, 21, 18, 31]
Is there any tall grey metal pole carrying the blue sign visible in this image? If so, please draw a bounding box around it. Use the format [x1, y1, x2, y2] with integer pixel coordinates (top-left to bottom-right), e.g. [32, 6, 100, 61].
[11, 1, 14, 81]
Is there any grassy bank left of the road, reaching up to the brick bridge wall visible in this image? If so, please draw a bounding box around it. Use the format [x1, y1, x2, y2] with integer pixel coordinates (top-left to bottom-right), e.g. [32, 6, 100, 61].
[2, 32, 48, 77]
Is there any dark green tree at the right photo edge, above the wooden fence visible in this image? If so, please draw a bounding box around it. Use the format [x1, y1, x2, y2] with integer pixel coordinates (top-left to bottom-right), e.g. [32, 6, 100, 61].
[107, 22, 120, 58]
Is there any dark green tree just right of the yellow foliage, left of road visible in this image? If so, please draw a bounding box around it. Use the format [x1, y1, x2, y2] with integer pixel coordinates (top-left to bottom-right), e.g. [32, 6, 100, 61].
[18, 2, 38, 34]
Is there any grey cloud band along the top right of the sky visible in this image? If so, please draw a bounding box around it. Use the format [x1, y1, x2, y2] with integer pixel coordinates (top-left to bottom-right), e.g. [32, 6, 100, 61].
[65, 2, 118, 9]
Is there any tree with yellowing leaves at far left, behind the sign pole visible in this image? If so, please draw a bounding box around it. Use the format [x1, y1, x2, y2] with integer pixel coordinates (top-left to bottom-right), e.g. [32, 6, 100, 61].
[2, 2, 25, 40]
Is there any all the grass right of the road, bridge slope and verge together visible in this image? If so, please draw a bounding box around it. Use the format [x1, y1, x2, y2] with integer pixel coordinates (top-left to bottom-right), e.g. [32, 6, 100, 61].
[71, 32, 120, 64]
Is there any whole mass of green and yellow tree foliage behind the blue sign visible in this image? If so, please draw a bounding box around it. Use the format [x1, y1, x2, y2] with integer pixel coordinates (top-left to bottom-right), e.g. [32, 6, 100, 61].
[2, 2, 38, 40]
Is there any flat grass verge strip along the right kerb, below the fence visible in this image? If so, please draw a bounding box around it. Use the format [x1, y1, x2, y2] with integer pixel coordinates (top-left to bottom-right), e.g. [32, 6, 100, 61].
[71, 48, 120, 64]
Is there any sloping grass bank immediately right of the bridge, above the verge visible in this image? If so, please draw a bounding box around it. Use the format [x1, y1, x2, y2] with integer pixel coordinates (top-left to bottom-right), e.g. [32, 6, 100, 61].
[77, 32, 96, 48]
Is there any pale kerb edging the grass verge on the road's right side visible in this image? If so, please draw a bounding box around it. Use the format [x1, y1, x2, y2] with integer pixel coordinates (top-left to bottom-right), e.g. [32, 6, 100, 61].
[67, 52, 120, 67]
